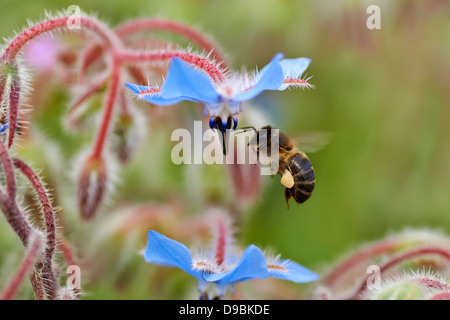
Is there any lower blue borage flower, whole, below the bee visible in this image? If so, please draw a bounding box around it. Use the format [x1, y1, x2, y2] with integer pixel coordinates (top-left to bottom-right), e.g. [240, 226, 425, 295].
[144, 230, 319, 298]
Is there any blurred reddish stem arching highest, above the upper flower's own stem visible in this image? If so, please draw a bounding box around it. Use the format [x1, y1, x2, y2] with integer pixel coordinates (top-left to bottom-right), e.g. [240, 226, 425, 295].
[115, 18, 226, 66]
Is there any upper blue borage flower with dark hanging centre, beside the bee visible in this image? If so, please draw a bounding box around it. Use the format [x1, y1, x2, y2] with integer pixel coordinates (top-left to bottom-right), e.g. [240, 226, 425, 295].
[126, 53, 312, 133]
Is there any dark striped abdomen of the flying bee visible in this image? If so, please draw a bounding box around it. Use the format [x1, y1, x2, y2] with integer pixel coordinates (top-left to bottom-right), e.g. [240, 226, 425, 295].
[286, 152, 316, 204]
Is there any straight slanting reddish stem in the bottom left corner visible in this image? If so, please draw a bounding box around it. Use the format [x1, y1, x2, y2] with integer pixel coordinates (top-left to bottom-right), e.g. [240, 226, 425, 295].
[0, 233, 42, 300]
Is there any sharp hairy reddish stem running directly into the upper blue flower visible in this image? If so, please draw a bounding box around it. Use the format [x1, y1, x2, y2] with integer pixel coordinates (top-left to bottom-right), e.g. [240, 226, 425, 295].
[119, 50, 225, 82]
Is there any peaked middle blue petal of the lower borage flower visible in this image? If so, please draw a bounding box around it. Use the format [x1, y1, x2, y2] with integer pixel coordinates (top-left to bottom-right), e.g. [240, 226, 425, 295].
[203, 245, 268, 285]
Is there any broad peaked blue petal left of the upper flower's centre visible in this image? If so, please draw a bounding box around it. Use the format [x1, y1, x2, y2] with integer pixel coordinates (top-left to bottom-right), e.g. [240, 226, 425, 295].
[161, 58, 220, 103]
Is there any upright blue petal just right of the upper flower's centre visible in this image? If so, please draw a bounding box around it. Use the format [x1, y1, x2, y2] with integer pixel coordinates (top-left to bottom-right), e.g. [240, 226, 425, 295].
[232, 53, 284, 101]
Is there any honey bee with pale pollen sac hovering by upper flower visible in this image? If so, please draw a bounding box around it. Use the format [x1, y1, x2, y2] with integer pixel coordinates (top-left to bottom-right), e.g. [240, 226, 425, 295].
[244, 125, 328, 208]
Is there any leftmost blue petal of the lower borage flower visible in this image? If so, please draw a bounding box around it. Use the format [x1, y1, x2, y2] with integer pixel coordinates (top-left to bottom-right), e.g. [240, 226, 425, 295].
[144, 230, 202, 279]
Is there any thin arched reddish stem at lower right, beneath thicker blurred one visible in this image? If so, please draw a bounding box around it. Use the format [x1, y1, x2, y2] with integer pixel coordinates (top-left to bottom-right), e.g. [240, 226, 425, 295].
[346, 246, 450, 300]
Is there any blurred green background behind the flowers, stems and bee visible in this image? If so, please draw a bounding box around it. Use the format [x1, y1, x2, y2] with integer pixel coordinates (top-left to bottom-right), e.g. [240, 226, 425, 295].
[0, 0, 450, 299]
